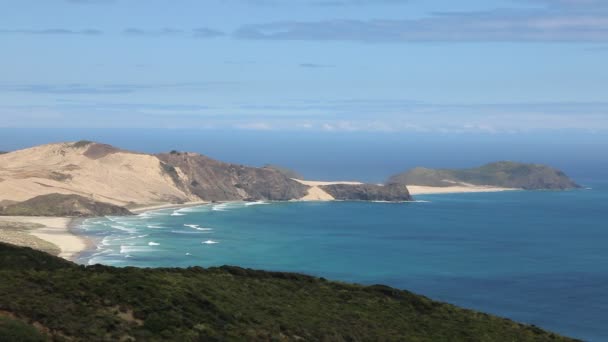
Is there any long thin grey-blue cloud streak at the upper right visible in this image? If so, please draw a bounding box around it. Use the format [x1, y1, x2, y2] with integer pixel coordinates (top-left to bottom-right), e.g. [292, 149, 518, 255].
[234, 0, 608, 42]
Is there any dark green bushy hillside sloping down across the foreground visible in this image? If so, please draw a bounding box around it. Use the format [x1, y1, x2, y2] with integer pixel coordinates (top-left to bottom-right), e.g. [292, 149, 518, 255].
[0, 243, 570, 341]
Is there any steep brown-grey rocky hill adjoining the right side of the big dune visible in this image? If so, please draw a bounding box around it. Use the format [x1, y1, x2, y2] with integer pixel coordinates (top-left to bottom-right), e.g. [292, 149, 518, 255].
[157, 151, 309, 201]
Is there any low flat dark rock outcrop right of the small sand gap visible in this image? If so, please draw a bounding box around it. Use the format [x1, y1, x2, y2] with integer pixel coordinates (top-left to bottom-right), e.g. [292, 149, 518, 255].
[319, 184, 412, 202]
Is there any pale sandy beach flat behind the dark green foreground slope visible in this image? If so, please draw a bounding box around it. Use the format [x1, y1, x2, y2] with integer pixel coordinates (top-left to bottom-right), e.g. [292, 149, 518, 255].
[0, 216, 87, 260]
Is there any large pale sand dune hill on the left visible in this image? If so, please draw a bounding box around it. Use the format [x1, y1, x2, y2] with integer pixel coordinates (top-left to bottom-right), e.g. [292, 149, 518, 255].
[0, 143, 198, 206]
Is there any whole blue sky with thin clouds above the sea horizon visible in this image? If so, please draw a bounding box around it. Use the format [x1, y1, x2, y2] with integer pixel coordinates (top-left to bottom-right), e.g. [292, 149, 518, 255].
[0, 0, 608, 134]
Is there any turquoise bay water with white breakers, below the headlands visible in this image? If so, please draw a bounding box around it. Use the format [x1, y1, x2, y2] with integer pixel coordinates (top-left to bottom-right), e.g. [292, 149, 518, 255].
[80, 183, 608, 341]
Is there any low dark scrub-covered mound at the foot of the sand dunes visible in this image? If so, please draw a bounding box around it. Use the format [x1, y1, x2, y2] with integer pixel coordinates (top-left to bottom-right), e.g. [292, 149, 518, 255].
[0, 194, 131, 217]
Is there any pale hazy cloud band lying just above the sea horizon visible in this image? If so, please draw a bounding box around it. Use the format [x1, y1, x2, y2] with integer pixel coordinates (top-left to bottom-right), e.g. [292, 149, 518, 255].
[0, 100, 608, 134]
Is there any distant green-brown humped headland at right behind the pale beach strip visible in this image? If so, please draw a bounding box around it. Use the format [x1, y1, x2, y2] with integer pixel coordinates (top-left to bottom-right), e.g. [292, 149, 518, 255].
[388, 161, 580, 190]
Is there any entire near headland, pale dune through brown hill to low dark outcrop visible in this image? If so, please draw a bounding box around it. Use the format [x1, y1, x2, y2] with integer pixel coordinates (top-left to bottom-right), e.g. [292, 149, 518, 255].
[0, 141, 410, 216]
